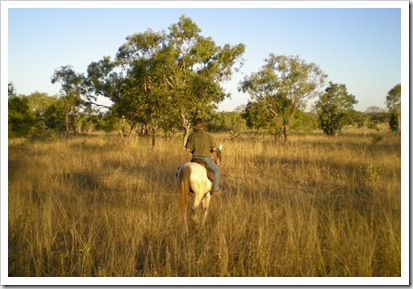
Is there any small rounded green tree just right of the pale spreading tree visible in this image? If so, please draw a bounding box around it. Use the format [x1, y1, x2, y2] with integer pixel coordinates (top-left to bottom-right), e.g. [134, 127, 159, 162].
[316, 82, 357, 135]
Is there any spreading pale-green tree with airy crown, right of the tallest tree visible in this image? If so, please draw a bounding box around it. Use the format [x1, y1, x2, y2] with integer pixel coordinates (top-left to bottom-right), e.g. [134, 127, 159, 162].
[239, 53, 327, 142]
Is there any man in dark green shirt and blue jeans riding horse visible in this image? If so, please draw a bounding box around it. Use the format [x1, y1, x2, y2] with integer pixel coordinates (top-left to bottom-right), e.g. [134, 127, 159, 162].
[185, 118, 221, 195]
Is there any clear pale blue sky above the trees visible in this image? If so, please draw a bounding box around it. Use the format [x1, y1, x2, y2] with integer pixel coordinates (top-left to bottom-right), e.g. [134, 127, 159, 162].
[4, 2, 402, 111]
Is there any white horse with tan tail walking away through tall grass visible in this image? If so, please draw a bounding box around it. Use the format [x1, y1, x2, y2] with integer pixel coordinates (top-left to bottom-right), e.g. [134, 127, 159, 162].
[176, 145, 222, 224]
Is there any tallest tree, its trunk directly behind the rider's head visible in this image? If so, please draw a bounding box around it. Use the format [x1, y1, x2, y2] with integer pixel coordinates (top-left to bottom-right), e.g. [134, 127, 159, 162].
[167, 16, 245, 143]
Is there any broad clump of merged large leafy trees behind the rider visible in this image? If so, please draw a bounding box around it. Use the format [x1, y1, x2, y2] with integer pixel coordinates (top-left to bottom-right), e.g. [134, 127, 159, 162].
[114, 16, 245, 145]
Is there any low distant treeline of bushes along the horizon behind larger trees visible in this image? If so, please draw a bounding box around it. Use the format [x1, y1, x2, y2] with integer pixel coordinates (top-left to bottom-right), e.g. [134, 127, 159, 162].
[8, 88, 391, 140]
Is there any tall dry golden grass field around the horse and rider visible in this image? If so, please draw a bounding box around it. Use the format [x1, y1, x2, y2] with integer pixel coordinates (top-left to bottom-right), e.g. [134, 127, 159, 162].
[8, 130, 401, 277]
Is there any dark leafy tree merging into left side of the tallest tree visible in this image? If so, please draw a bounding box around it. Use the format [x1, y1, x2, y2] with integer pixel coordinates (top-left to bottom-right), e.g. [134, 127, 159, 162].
[112, 29, 171, 145]
